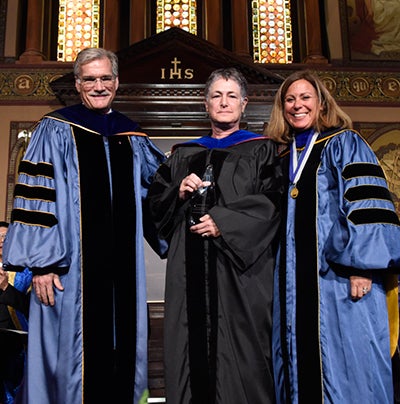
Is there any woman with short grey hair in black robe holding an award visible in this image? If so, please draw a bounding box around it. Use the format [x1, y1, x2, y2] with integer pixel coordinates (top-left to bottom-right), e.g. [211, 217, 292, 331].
[148, 69, 281, 404]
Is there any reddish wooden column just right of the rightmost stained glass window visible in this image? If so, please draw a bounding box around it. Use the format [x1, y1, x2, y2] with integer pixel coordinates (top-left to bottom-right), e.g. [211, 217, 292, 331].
[304, 0, 328, 63]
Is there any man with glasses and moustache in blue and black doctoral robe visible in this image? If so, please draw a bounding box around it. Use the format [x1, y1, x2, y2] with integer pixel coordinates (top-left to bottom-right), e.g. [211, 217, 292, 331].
[4, 48, 165, 404]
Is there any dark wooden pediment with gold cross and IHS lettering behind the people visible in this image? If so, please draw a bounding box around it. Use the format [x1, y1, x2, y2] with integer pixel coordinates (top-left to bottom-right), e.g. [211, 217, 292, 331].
[51, 28, 283, 135]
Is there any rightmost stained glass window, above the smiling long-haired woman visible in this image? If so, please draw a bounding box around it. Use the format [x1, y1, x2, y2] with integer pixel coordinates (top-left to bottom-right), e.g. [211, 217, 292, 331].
[251, 0, 293, 63]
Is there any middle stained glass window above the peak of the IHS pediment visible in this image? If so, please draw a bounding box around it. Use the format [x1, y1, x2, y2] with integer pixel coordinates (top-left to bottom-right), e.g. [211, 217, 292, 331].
[157, 0, 197, 35]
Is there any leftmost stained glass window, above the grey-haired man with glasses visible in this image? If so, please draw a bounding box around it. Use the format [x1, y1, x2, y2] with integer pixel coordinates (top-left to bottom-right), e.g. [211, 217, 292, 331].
[57, 0, 100, 62]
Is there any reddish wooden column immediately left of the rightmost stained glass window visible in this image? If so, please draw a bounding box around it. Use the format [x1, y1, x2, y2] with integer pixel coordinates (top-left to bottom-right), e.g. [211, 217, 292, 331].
[231, 0, 253, 59]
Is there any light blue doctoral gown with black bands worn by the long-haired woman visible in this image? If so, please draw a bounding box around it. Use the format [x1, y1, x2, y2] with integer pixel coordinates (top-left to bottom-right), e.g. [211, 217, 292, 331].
[273, 130, 400, 404]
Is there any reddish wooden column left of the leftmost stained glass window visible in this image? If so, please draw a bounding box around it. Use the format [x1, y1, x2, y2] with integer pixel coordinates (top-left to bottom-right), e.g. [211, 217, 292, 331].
[19, 0, 45, 63]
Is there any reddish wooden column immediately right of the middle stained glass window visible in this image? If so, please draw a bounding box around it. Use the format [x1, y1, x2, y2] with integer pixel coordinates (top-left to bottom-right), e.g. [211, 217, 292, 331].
[205, 0, 224, 48]
